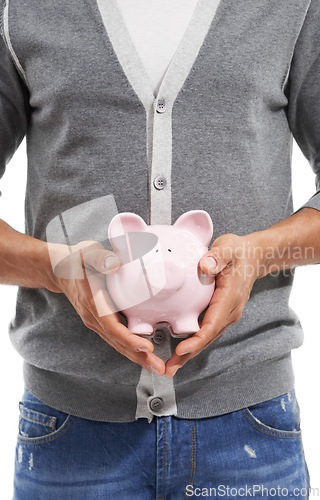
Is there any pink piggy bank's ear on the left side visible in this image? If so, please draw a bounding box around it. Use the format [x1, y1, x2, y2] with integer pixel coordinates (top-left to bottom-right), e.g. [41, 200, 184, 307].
[108, 212, 158, 264]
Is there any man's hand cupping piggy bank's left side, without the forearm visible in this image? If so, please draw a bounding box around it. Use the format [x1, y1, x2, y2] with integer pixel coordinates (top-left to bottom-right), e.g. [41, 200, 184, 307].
[48, 241, 165, 375]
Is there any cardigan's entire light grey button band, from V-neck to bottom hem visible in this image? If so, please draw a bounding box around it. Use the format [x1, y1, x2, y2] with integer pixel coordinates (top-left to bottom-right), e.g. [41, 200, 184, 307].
[97, 0, 221, 421]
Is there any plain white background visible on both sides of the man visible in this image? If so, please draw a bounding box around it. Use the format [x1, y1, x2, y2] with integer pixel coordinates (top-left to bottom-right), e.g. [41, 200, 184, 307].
[0, 140, 320, 500]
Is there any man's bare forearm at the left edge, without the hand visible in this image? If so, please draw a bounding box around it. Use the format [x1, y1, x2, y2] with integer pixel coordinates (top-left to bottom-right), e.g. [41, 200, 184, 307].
[0, 219, 55, 291]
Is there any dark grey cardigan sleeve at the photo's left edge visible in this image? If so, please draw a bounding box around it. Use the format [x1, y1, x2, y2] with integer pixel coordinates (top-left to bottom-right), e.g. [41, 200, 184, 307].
[0, 29, 29, 182]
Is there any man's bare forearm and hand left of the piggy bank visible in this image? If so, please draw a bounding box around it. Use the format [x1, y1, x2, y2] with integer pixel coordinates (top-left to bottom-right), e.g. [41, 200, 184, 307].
[0, 220, 165, 375]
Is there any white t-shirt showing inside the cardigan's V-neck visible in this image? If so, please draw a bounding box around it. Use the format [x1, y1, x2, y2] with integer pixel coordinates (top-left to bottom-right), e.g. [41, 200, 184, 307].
[117, 0, 198, 92]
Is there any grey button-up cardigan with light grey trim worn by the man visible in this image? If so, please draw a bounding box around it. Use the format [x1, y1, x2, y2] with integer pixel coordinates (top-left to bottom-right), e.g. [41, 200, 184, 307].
[0, 0, 320, 422]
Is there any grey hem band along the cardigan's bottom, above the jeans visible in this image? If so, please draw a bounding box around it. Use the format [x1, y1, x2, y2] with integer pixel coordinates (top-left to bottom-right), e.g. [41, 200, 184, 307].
[24, 352, 295, 422]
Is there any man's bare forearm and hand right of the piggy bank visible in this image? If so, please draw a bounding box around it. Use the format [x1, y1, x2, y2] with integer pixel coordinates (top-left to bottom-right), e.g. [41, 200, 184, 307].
[165, 208, 320, 377]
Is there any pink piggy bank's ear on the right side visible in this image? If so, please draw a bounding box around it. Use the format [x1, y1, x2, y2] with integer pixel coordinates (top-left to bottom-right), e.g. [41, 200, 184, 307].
[173, 210, 213, 247]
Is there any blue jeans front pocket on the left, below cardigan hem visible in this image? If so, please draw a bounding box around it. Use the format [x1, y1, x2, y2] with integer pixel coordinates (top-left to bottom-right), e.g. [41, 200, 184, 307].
[18, 389, 75, 444]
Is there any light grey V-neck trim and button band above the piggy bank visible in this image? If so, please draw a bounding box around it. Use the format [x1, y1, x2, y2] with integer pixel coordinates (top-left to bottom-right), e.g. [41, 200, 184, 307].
[97, 0, 221, 224]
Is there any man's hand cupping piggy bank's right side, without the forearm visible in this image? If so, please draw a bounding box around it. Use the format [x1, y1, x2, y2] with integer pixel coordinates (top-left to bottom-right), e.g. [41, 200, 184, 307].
[165, 234, 260, 377]
